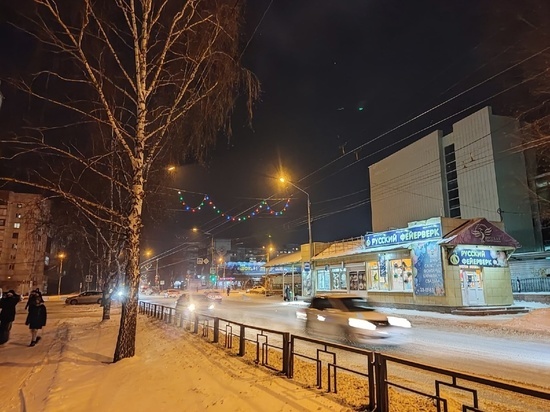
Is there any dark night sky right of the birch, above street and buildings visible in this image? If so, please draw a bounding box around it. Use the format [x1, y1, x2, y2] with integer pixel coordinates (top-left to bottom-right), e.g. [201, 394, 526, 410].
[0, 0, 544, 253]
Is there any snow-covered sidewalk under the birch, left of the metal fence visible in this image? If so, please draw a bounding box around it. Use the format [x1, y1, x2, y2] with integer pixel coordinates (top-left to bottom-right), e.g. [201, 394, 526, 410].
[0, 302, 351, 412]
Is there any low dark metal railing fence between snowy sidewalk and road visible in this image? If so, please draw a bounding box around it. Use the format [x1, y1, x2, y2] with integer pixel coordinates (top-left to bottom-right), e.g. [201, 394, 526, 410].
[139, 302, 550, 412]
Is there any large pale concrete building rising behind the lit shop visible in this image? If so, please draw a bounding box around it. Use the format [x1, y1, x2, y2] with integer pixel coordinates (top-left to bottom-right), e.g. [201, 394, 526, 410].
[369, 107, 543, 253]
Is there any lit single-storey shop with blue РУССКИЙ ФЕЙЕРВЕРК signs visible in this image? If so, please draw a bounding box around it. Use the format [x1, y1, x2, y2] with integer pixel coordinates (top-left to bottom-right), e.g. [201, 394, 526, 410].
[313, 217, 519, 307]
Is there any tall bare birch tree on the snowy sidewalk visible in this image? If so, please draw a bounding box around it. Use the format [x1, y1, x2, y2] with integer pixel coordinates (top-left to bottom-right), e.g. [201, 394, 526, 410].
[1, 0, 259, 362]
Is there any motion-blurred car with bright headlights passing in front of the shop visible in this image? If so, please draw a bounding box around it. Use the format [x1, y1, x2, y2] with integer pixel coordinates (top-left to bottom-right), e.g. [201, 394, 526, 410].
[296, 295, 411, 345]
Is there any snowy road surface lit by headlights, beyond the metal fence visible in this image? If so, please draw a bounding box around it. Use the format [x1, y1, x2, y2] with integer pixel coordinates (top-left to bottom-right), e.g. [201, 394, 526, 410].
[142, 293, 550, 391]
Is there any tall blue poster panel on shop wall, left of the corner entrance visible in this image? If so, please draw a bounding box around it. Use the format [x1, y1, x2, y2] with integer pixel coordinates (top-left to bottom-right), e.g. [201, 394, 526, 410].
[411, 242, 445, 296]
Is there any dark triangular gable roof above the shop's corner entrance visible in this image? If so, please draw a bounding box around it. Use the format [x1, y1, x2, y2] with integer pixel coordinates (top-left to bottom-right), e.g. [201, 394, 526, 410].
[439, 218, 521, 249]
